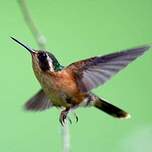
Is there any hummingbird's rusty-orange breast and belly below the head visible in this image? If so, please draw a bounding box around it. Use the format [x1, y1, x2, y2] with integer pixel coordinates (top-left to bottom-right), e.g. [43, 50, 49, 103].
[33, 58, 86, 107]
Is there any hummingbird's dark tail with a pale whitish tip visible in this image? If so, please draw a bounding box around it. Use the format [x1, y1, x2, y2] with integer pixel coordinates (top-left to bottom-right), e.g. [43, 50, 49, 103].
[94, 97, 130, 119]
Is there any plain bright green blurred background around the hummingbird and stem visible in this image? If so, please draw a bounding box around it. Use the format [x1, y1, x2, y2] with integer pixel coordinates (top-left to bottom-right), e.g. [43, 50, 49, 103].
[0, 0, 152, 152]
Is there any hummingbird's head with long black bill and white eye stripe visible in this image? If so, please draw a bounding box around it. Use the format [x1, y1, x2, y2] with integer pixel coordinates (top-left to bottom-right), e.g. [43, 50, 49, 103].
[11, 37, 63, 72]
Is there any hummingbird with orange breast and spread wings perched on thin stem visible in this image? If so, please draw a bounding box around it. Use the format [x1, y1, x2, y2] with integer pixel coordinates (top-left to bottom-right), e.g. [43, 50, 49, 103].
[11, 37, 151, 126]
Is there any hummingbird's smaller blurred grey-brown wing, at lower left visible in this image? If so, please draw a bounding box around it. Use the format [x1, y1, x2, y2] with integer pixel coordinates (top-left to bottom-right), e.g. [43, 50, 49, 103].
[25, 89, 52, 111]
